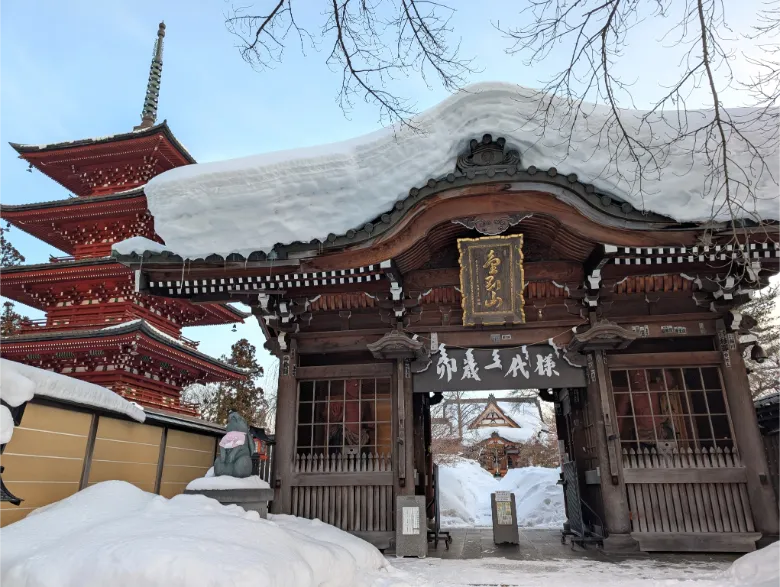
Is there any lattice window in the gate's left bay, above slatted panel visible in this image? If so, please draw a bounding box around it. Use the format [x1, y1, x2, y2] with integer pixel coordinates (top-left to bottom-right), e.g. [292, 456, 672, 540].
[296, 378, 392, 456]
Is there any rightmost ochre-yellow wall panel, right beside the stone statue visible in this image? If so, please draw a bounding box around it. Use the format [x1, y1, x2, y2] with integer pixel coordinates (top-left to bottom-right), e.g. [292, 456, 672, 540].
[160, 430, 217, 497]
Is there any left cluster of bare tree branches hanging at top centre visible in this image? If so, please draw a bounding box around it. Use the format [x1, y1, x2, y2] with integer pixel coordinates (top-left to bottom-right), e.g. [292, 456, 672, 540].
[225, 0, 475, 128]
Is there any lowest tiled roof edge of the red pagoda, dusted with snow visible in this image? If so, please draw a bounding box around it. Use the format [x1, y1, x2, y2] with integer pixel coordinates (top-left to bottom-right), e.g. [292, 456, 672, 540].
[0, 318, 247, 375]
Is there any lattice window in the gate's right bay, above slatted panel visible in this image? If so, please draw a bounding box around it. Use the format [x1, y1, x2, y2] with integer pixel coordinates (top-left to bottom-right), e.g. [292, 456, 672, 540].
[611, 367, 734, 450]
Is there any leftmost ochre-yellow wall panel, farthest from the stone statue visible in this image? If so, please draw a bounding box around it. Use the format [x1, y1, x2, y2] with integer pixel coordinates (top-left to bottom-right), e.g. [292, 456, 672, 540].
[0, 404, 92, 526]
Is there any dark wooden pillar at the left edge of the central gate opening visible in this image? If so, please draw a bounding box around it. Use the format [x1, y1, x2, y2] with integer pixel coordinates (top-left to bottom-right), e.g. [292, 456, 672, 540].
[394, 359, 414, 495]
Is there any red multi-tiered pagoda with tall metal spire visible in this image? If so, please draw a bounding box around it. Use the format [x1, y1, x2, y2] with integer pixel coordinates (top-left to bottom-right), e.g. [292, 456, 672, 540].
[0, 23, 247, 414]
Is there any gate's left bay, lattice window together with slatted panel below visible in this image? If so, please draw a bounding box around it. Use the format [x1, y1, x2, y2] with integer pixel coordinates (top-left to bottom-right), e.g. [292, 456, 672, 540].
[289, 374, 395, 548]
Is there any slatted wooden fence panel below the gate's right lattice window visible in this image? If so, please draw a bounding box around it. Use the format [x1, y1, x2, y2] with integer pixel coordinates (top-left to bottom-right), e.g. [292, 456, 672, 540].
[623, 448, 755, 534]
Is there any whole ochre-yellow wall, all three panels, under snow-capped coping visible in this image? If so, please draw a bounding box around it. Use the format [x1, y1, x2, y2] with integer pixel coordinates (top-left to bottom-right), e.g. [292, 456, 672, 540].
[0, 403, 217, 527]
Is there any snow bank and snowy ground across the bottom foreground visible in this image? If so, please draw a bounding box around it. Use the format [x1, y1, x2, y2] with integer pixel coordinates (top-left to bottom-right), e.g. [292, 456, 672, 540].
[0, 481, 780, 587]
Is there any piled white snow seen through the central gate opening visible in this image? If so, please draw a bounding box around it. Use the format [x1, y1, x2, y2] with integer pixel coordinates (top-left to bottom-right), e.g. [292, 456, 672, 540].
[439, 459, 566, 528]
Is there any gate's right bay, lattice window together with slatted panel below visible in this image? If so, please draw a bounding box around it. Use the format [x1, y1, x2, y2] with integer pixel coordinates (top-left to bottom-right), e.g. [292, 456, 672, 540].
[611, 366, 761, 552]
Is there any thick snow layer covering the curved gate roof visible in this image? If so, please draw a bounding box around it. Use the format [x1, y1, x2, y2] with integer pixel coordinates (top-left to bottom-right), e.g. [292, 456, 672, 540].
[109, 83, 780, 261]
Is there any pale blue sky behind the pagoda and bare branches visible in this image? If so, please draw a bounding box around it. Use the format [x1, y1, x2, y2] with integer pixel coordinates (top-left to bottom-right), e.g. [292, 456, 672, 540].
[0, 0, 772, 384]
